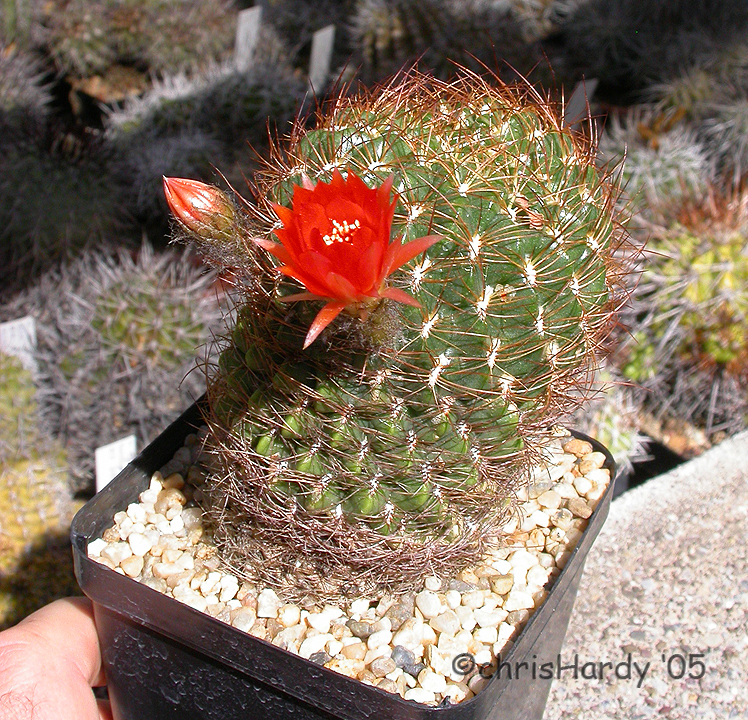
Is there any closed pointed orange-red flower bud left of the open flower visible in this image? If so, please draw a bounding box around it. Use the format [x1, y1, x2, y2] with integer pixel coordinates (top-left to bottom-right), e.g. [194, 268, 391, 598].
[164, 177, 233, 235]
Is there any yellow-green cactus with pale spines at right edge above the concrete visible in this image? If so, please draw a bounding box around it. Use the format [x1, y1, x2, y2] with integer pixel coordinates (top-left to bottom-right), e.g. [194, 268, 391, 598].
[617, 191, 748, 435]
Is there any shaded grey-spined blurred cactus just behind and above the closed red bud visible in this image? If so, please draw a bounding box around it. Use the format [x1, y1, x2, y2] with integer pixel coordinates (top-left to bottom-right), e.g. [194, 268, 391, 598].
[107, 41, 307, 235]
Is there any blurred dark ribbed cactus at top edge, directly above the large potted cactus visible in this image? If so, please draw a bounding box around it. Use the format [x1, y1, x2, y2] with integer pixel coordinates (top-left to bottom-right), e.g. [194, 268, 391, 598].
[351, 0, 543, 86]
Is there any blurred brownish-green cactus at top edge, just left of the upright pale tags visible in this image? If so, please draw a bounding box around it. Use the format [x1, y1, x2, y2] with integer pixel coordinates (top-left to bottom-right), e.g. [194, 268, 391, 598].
[44, 0, 237, 77]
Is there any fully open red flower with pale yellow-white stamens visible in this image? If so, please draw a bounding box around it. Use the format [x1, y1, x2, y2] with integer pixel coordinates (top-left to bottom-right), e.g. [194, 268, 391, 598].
[255, 170, 441, 348]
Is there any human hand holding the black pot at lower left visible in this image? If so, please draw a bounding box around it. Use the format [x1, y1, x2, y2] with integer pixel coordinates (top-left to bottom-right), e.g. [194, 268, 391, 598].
[0, 598, 112, 720]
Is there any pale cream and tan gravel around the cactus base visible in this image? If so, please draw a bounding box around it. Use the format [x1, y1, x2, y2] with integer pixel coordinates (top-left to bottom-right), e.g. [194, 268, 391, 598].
[88, 433, 611, 705]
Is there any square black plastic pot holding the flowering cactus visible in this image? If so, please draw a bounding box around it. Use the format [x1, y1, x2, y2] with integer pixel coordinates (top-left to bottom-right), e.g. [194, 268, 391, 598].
[71, 405, 615, 720]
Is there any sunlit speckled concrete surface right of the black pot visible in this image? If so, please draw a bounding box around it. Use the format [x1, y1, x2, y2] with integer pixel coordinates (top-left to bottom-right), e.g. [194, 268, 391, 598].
[544, 432, 748, 720]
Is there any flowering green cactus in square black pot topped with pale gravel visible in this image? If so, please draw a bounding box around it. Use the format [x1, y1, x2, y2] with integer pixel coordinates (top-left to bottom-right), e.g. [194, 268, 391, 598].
[73, 73, 623, 718]
